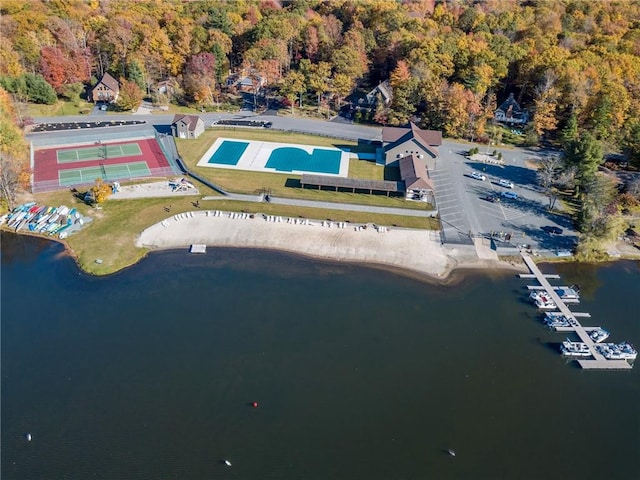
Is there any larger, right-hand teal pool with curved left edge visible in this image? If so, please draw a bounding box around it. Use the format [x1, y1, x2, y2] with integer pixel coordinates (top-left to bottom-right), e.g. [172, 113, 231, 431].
[265, 147, 341, 174]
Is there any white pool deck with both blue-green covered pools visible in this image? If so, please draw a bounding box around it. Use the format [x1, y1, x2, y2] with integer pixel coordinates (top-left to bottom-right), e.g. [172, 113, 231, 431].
[198, 138, 349, 177]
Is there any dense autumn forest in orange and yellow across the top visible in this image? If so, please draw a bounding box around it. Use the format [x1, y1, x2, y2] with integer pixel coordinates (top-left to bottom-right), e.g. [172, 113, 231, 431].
[0, 0, 640, 256]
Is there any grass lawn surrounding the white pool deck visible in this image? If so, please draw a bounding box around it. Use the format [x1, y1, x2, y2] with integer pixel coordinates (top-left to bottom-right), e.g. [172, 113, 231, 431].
[176, 129, 431, 210]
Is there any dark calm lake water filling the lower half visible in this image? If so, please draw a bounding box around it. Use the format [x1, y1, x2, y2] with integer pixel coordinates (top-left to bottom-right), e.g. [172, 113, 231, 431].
[1, 233, 640, 480]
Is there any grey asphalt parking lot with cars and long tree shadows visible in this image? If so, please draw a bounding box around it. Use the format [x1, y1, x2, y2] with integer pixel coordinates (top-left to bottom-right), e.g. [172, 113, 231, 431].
[431, 142, 576, 252]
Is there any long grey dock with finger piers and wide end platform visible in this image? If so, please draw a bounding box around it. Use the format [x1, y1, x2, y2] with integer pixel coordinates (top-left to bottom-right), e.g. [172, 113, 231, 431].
[520, 252, 633, 370]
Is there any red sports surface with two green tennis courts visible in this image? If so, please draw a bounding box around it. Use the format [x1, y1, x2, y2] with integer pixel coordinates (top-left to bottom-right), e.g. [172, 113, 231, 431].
[33, 138, 174, 193]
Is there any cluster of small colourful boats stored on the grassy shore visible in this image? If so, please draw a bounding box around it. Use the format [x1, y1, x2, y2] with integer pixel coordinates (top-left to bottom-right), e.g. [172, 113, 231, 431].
[4, 202, 83, 237]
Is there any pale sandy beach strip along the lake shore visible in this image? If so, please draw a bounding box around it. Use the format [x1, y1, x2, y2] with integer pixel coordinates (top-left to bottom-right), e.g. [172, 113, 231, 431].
[136, 211, 508, 278]
